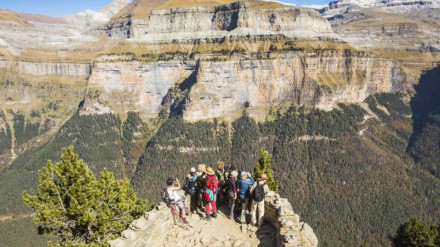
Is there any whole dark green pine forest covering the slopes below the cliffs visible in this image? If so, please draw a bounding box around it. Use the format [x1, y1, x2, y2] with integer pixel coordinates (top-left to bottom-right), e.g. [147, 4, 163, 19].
[0, 63, 440, 246]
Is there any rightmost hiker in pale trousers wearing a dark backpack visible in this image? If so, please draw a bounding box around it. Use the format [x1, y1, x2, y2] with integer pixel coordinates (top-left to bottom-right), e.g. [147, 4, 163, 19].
[250, 173, 269, 227]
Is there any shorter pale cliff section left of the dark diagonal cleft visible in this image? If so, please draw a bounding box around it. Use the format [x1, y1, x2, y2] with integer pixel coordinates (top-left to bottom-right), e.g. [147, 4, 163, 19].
[82, 57, 195, 117]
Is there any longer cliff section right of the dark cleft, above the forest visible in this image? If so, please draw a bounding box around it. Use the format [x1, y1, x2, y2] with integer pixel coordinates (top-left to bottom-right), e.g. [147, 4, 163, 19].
[184, 51, 402, 121]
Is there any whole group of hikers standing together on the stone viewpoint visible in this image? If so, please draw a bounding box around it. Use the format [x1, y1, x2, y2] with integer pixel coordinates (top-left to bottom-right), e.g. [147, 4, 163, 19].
[162, 161, 269, 227]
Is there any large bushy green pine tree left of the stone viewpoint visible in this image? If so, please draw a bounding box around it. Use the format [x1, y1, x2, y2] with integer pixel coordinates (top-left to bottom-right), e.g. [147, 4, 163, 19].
[22, 146, 148, 246]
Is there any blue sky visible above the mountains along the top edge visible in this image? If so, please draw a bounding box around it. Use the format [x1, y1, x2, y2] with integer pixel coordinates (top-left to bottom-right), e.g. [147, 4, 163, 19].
[0, 0, 330, 17]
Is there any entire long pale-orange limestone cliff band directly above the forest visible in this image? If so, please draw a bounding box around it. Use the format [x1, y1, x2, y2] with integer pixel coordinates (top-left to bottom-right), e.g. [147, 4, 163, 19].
[84, 50, 405, 121]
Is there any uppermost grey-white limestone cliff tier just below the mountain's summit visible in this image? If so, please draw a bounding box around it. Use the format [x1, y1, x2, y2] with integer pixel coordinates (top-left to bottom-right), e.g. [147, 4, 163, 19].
[107, 2, 336, 42]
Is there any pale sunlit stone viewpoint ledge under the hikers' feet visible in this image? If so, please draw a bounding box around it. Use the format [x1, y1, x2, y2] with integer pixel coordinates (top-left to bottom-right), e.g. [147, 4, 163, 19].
[110, 192, 318, 247]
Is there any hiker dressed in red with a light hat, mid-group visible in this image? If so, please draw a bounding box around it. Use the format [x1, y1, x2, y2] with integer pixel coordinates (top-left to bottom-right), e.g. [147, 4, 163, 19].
[198, 167, 218, 221]
